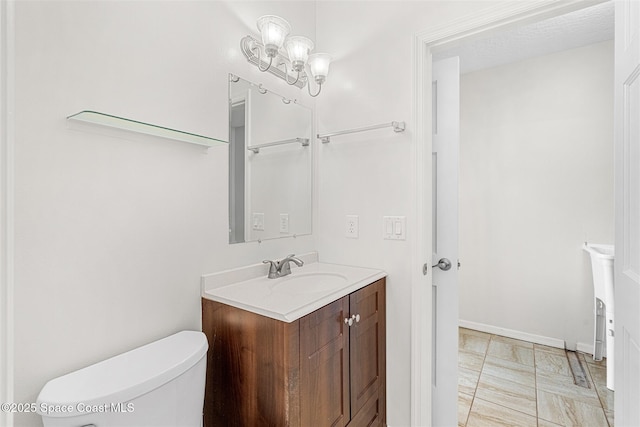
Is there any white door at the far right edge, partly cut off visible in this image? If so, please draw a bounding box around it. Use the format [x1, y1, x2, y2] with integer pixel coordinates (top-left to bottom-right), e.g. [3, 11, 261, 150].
[614, 0, 640, 426]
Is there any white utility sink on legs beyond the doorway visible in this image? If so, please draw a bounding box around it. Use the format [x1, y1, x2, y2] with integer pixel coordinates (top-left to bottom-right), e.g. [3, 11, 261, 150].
[583, 243, 615, 390]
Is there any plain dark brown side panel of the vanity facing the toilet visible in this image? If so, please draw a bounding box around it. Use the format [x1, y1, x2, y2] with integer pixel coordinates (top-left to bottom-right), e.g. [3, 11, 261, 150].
[202, 298, 300, 427]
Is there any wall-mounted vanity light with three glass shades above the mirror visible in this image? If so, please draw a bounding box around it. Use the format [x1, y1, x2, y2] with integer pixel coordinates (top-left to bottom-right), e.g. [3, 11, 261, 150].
[240, 15, 331, 97]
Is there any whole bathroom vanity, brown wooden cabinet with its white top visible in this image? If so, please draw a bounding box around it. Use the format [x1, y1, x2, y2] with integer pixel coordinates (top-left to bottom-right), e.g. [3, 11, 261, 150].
[202, 256, 386, 427]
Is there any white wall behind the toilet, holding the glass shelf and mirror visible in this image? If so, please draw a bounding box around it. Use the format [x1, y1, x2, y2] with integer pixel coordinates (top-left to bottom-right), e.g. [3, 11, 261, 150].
[13, 1, 316, 426]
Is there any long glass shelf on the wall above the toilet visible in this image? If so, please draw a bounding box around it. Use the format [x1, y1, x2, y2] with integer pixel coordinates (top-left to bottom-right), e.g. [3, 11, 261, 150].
[67, 110, 227, 147]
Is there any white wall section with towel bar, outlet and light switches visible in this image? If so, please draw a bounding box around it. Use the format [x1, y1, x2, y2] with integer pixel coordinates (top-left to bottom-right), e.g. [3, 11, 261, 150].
[316, 1, 492, 426]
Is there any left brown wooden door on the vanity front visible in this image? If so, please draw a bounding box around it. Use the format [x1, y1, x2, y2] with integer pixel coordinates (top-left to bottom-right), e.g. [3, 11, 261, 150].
[299, 296, 350, 427]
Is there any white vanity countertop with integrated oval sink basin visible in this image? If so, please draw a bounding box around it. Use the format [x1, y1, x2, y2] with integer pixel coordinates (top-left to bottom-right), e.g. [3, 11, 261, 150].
[202, 253, 387, 322]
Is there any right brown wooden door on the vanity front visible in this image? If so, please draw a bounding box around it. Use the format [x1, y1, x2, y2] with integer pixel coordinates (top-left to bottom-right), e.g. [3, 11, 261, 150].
[349, 279, 386, 425]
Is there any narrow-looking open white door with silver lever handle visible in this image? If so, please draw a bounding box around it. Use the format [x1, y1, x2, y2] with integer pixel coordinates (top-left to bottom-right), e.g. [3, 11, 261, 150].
[432, 57, 460, 426]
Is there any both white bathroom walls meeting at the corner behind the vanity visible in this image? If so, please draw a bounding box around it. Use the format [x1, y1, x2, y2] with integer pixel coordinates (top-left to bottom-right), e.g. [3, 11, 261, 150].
[6, 1, 524, 426]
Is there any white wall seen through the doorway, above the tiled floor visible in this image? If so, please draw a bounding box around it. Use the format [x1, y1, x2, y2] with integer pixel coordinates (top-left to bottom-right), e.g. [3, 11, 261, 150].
[460, 42, 614, 348]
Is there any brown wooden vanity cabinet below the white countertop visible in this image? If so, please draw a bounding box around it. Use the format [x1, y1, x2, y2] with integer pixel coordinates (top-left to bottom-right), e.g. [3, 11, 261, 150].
[202, 278, 386, 427]
